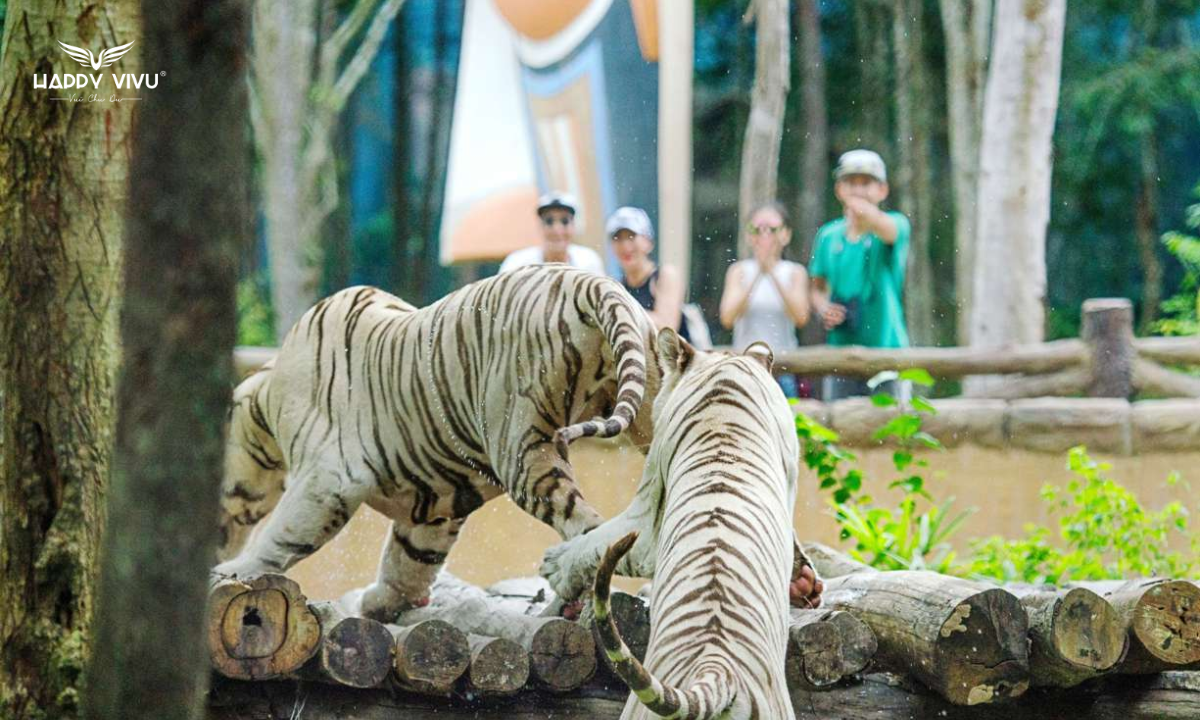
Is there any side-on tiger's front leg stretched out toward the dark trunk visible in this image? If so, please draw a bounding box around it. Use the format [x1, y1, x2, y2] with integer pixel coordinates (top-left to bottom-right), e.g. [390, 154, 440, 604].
[212, 469, 368, 577]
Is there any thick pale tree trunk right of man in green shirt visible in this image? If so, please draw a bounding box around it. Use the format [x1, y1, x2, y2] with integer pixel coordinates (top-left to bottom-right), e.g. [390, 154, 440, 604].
[971, 0, 1067, 360]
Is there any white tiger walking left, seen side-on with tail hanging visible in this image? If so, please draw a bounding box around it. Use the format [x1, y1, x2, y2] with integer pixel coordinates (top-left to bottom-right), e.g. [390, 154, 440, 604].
[214, 265, 658, 618]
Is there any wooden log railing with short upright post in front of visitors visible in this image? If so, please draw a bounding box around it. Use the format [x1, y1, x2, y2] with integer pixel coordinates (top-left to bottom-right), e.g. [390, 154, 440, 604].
[234, 298, 1200, 400]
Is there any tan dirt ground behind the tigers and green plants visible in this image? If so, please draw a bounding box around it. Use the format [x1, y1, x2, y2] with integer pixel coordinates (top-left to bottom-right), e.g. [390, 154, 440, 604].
[288, 440, 1200, 600]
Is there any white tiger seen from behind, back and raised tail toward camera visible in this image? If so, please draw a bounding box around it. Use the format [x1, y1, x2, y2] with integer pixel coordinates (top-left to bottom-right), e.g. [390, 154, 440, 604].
[560, 330, 806, 720]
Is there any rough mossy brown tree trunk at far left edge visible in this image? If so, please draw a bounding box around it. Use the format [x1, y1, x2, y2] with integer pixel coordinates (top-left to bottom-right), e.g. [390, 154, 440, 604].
[0, 0, 137, 718]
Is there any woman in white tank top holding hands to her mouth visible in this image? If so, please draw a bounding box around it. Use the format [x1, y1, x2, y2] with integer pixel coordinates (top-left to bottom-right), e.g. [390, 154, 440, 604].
[720, 202, 809, 397]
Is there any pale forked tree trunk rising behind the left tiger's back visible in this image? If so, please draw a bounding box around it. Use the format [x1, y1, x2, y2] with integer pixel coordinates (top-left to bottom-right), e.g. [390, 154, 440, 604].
[250, 0, 403, 340]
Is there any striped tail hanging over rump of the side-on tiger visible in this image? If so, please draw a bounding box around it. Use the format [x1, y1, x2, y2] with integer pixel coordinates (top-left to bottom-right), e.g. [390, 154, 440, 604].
[554, 281, 648, 460]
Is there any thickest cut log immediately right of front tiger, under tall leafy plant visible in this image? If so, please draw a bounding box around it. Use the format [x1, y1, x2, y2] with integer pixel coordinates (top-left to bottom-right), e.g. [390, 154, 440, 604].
[823, 571, 1030, 706]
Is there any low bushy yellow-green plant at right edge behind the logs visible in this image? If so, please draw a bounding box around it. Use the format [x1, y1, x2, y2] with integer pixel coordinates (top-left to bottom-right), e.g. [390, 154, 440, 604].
[962, 446, 1200, 584]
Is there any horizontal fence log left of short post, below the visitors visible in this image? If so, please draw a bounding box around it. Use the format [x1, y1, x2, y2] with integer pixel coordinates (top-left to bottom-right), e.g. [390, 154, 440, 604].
[775, 340, 1087, 378]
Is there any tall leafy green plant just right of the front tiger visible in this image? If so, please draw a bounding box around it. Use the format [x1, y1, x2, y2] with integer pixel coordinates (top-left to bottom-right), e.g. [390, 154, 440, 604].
[796, 370, 973, 572]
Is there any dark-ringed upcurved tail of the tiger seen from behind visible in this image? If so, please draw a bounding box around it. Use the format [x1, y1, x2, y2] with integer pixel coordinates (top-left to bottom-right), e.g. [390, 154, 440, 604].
[592, 533, 733, 719]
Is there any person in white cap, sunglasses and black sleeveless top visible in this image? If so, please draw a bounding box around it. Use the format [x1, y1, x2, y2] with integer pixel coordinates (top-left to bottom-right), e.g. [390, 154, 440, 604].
[604, 205, 691, 341]
